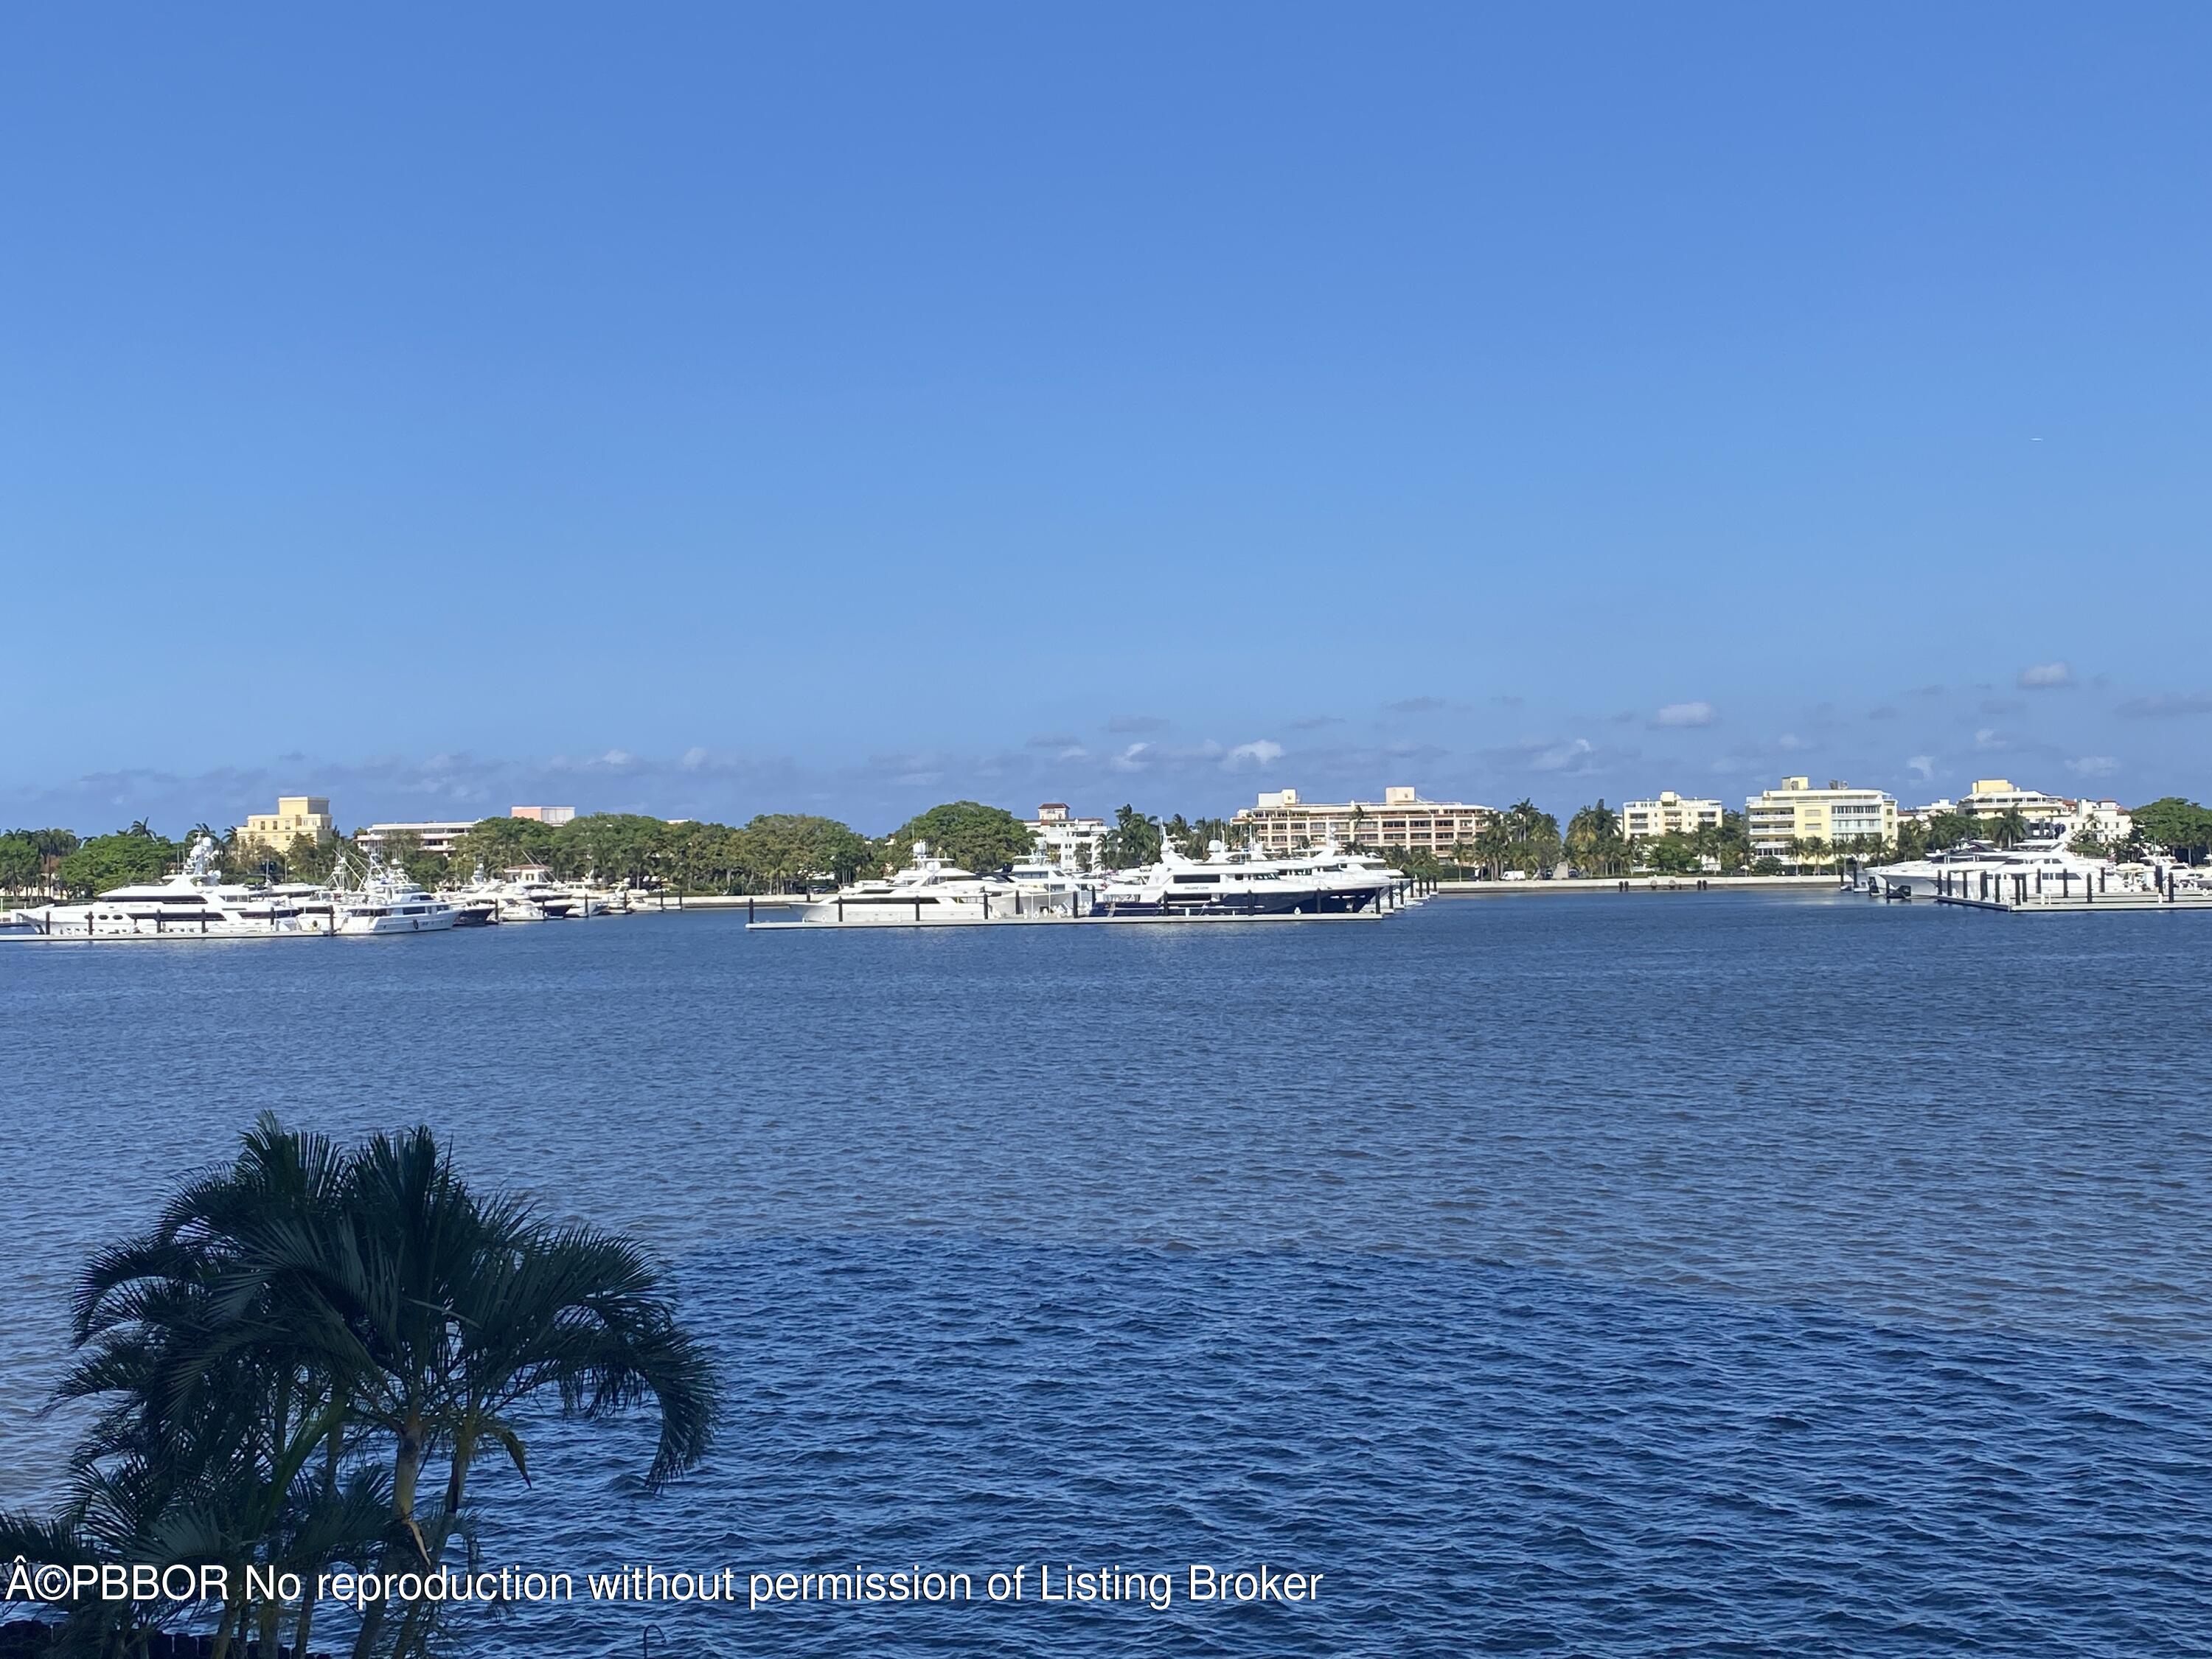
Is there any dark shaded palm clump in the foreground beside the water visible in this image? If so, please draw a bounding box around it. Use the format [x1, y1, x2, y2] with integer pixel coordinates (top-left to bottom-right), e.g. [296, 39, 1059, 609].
[0, 1115, 717, 1659]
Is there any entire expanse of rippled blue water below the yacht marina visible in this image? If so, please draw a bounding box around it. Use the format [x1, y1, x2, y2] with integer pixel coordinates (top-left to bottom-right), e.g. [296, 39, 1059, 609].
[0, 896, 2212, 1655]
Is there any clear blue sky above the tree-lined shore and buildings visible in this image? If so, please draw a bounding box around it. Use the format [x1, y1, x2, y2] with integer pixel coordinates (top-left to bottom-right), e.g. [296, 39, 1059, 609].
[0, 4, 2212, 830]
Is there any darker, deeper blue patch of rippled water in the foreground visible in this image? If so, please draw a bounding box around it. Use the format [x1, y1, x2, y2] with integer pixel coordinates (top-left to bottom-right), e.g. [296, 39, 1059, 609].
[453, 1234, 2212, 1655]
